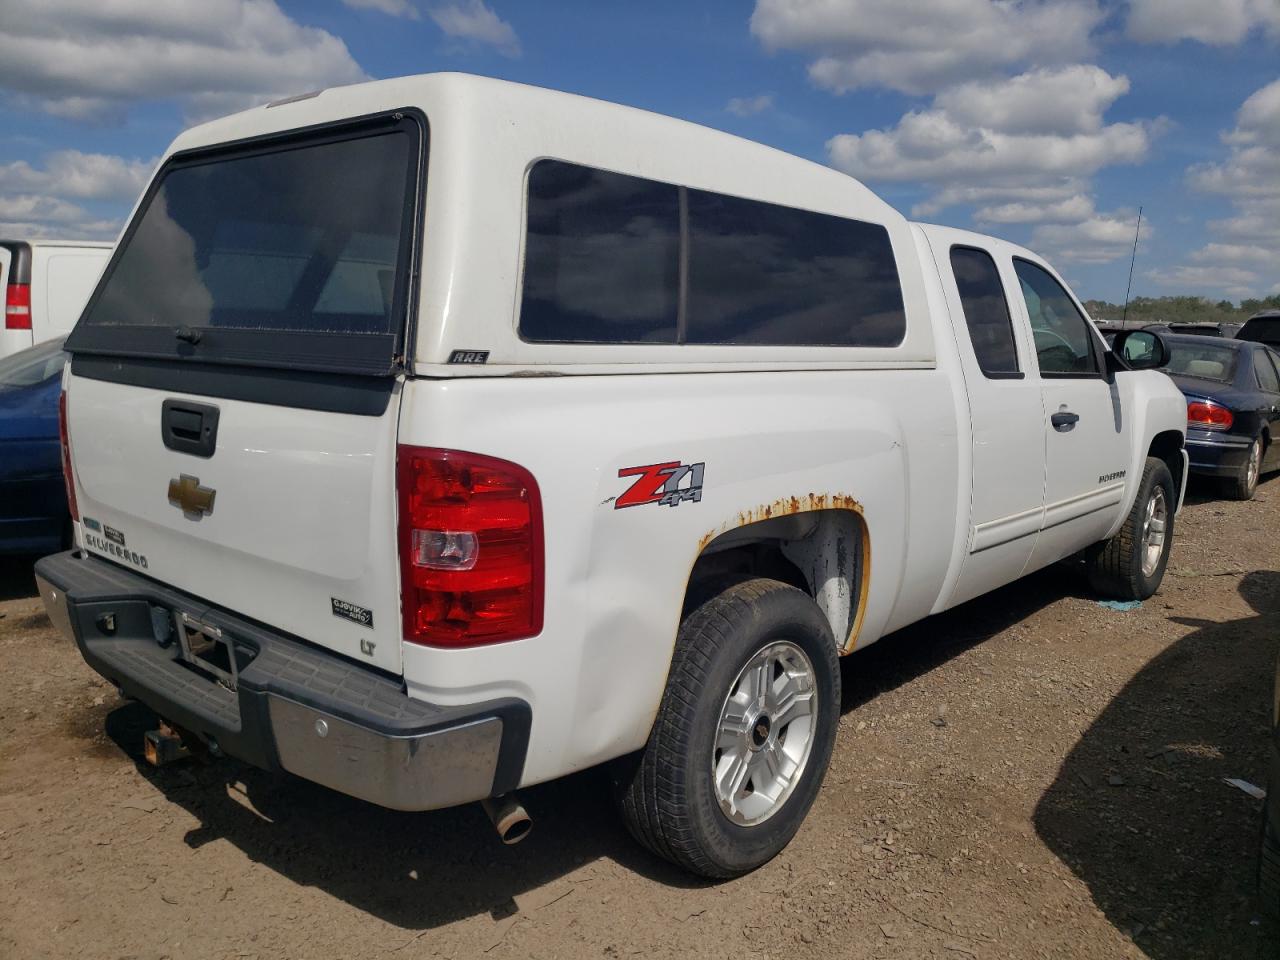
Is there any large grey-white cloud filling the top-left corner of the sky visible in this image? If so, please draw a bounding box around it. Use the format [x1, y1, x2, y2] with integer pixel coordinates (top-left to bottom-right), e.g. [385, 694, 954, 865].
[0, 0, 367, 120]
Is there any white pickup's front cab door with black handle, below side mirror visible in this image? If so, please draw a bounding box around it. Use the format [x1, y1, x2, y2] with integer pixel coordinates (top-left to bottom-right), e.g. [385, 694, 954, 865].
[1012, 257, 1133, 572]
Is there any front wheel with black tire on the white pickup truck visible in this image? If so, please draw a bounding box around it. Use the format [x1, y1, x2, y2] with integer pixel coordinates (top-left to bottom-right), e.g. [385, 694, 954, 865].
[1085, 457, 1178, 600]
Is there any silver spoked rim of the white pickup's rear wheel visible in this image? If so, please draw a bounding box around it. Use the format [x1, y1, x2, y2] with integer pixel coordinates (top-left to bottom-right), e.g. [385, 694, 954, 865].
[712, 640, 818, 827]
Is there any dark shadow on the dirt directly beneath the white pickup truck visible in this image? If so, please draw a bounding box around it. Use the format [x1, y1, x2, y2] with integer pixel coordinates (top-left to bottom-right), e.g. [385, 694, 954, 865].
[87, 570, 1083, 929]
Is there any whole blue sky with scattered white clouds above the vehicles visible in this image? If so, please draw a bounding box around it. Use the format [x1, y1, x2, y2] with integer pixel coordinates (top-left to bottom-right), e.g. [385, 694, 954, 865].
[0, 0, 1280, 302]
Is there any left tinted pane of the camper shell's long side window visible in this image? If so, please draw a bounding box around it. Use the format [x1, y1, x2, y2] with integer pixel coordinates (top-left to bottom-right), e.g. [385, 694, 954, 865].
[520, 160, 680, 343]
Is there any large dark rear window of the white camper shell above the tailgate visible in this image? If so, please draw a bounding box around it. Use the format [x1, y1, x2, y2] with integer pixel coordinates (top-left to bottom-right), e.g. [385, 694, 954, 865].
[67, 110, 426, 375]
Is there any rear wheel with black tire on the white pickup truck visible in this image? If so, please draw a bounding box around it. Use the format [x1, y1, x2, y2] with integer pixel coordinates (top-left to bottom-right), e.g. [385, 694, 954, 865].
[613, 579, 840, 879]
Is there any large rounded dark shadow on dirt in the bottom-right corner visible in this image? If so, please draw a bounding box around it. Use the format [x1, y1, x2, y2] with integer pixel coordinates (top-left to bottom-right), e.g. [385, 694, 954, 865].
[1036, 571, 1280, 960]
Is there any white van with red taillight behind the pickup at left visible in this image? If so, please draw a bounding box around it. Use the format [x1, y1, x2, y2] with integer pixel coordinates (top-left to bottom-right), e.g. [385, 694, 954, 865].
[0, 239, 111, 357]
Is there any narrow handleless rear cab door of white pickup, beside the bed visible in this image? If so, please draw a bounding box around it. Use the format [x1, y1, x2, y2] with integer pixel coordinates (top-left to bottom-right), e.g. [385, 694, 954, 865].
[928, 229, 1044, 607]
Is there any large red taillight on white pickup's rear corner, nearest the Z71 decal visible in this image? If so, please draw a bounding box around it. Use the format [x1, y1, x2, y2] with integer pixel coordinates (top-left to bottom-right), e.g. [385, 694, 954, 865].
[396, 445, 543, 646]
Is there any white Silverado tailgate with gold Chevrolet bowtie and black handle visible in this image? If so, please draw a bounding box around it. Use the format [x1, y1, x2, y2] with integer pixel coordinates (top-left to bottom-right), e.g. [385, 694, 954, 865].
[67, 364, 401, 673]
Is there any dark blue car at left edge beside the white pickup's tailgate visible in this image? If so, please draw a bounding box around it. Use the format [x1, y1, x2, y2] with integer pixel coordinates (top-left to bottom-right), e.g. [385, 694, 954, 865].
[0, 339, 70, 553]
